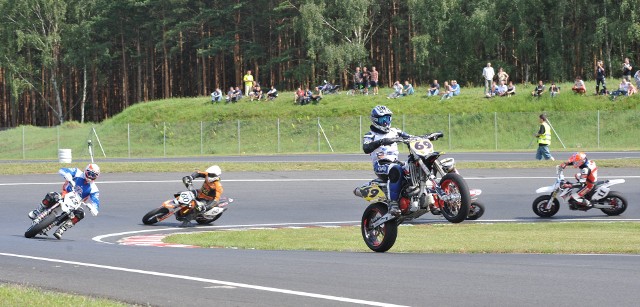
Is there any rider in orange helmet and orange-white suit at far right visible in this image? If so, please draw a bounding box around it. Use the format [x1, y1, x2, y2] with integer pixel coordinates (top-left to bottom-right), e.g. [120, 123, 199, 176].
[559, 152, 598, 207]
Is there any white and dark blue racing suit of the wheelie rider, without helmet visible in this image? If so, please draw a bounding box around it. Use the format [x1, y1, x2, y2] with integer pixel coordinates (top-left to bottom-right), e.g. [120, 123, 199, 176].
[362, 126, 411, 213]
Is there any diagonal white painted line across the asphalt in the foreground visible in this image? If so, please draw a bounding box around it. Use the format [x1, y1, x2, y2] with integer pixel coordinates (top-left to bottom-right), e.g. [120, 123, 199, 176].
[0, 253, 403, 307]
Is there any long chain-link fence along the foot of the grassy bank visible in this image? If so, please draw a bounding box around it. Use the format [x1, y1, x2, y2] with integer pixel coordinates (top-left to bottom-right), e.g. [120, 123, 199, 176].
[0, 111, 640, 160]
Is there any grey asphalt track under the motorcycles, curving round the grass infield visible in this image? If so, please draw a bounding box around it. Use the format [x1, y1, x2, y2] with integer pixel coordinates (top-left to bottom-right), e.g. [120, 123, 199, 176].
[0, 169, 640, 306]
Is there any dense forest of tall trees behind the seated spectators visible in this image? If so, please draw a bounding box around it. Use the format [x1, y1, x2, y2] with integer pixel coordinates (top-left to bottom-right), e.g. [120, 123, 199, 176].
[0, 0, 640, 127]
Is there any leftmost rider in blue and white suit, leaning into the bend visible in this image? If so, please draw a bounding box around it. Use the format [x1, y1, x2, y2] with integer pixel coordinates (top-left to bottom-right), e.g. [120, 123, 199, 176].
[28, 163, 100, 240]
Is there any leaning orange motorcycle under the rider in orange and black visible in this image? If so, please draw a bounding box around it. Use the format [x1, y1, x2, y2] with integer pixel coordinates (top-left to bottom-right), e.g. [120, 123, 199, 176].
[142, 178, 233, 227]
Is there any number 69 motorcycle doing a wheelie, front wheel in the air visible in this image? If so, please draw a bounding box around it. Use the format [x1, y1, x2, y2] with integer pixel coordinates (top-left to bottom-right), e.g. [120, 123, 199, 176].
[354, 132, 471, 252]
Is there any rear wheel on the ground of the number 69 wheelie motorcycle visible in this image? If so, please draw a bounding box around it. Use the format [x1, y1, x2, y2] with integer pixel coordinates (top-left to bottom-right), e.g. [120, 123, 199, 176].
[360, 203, 398, 253]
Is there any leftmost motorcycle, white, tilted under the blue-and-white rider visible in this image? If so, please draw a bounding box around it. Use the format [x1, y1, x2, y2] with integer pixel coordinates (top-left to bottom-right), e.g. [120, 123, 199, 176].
[24, 190, 97, 238]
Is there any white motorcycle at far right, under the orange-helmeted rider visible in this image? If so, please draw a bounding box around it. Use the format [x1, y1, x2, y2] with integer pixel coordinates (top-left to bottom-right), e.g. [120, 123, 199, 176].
[532, 167, 627, 217]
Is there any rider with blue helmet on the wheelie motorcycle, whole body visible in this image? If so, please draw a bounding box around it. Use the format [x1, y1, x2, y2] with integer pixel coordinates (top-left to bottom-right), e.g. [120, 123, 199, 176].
[362, 106, 411, 216]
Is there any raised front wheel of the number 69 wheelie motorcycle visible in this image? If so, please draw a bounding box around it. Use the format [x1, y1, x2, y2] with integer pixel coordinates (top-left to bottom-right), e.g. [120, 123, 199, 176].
[440, 173, 471, 223]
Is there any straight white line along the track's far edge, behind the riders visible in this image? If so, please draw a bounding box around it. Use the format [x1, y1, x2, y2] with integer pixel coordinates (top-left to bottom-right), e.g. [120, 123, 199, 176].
[0, 176, 640, 186]
